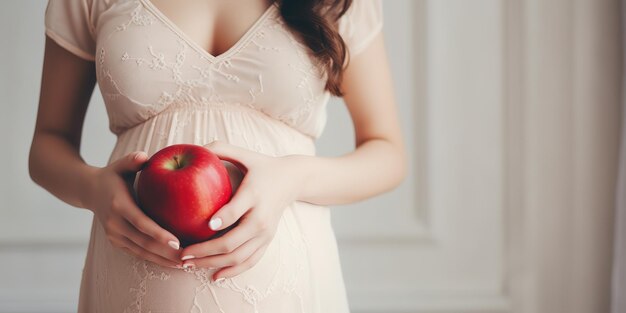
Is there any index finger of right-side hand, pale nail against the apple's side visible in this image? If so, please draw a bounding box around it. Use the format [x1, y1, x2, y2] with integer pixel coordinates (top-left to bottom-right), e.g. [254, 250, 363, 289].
[208, 186, 255, 231]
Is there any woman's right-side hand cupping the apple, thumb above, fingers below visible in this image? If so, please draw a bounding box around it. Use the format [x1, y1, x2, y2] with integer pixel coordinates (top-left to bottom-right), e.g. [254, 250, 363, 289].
[181, 141, 304, 280]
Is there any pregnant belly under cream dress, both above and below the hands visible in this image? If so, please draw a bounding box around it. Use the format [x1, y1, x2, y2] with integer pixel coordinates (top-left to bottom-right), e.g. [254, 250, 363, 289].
[85, 107, 338, 313]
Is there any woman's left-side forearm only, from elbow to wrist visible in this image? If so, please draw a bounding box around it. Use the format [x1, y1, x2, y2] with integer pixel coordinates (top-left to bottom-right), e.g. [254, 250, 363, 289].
[28, 132, 96, 208]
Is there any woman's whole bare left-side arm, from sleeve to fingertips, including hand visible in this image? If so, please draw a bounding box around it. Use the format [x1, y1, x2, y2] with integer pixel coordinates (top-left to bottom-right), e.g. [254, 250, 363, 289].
[28, 36, 180, 267]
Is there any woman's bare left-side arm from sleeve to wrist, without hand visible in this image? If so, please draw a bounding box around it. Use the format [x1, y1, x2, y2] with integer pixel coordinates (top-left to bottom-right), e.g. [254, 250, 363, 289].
[28, 36, 96, 208]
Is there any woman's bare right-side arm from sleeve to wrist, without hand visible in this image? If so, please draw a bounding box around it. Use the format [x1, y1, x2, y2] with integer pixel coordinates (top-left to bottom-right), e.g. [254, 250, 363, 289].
[294, 32, 407, 205]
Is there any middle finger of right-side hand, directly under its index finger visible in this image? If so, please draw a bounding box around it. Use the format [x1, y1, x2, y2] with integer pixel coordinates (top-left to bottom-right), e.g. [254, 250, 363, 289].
[180, 216, 256, 261]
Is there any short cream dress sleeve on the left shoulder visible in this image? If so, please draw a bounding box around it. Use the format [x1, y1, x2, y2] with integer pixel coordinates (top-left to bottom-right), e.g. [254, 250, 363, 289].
[44, 0, 96, 61]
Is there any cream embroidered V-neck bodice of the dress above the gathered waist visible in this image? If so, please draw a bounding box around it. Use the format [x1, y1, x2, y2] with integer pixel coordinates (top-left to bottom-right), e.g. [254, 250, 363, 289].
[96, 0, 329, 134]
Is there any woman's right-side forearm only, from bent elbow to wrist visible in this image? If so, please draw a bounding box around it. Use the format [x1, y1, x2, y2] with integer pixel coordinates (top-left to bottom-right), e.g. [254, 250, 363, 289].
[296, 139, 407, 205]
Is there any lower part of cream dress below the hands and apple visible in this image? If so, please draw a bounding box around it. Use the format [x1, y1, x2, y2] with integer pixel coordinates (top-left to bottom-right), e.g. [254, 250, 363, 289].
[86, 202, 326, 313]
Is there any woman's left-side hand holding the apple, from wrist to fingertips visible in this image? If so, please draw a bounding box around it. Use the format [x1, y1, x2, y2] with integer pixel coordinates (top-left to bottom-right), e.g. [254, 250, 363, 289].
[86, 152, 182, 268]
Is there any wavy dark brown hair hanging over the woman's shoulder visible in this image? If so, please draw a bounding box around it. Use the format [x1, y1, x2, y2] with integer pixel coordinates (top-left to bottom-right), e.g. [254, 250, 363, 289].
[276, 0, 352, 96]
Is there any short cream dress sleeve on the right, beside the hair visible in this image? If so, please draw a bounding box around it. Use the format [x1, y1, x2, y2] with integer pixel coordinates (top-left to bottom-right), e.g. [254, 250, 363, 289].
[338, 0, 383, 56]
